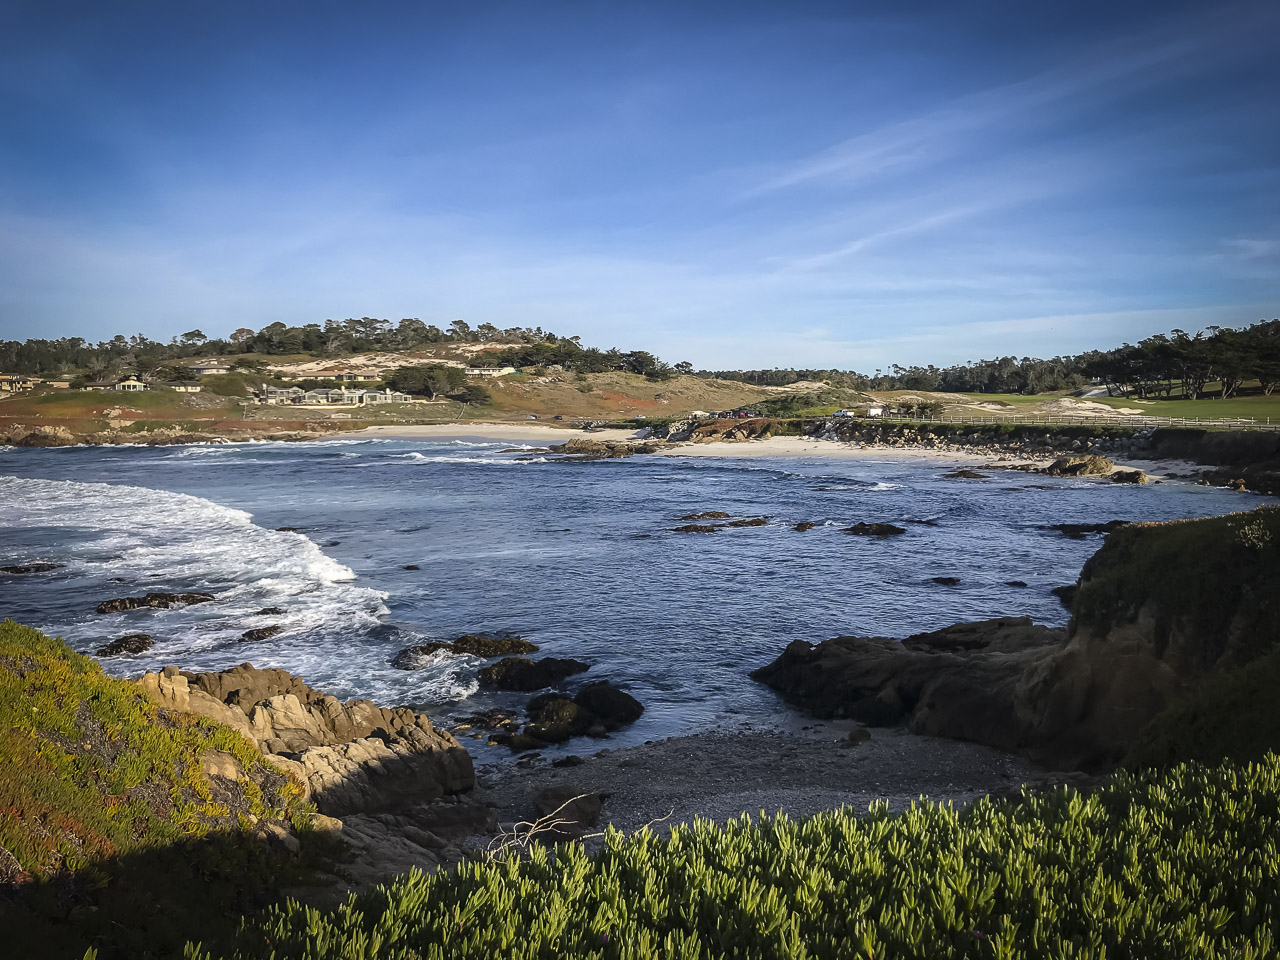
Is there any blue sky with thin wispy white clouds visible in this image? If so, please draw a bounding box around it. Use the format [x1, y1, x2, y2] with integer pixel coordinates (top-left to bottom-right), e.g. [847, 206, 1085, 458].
[0, 0, 1280, 371]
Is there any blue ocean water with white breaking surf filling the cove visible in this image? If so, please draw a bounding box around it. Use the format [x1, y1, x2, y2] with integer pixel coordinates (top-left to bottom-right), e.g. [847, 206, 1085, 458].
[0, 438, 1261, 745]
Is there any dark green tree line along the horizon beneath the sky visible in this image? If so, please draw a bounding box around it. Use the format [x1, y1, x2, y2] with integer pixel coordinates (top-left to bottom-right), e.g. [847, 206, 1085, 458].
[0, 316, 1280, 398]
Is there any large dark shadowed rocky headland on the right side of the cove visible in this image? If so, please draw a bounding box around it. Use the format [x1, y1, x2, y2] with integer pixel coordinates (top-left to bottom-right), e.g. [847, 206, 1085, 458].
[753, 507, 1280, 771]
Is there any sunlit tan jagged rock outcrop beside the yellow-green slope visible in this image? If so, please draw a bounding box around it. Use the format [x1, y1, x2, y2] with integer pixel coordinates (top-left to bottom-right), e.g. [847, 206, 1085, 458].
[138, 663, 475, 817]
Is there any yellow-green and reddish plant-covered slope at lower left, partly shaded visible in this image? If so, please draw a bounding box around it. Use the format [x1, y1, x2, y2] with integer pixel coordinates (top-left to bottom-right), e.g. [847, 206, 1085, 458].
[0, 621, 324, 959]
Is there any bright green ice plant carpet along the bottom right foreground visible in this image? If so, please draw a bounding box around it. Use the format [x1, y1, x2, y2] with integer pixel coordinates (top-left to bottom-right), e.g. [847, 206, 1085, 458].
[194, 754, 1280, 960]
